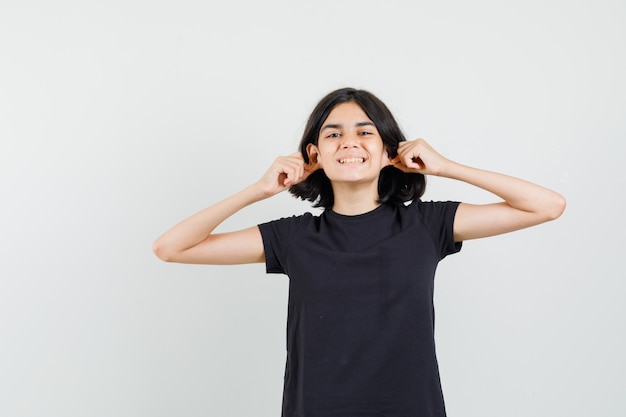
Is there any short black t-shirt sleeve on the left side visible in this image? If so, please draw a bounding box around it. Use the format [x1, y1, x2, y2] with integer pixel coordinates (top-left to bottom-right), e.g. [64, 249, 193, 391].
[258, 213, 312, 274]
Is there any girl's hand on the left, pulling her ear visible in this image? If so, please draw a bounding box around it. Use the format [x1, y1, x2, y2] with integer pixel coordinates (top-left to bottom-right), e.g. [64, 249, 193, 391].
[257, 152, 316, 197]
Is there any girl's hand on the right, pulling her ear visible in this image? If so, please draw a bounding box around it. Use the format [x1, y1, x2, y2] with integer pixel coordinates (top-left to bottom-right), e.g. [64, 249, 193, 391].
[391, 139, 450, 175]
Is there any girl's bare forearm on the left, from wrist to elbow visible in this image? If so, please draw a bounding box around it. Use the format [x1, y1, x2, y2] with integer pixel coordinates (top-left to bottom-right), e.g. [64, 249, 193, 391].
[153, 184, 268, 259]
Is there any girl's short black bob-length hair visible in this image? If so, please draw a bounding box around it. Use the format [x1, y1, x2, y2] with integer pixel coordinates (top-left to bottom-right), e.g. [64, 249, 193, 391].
[289, 88, 426, 209]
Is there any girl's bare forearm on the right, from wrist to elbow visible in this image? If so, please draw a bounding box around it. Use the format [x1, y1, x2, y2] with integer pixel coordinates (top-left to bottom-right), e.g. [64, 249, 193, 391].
[439, 161, 565, 220]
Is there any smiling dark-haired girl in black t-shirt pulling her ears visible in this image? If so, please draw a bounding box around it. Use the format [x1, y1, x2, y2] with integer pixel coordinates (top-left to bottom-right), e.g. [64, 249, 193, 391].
[154, 88, 565, 417]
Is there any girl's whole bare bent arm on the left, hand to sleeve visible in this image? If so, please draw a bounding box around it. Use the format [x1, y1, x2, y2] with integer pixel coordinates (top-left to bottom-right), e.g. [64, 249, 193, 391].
[152, 153, 310, 265]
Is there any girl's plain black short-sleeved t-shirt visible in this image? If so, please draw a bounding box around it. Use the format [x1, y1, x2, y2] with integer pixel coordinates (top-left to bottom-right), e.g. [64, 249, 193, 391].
[259, 201, 461, 417]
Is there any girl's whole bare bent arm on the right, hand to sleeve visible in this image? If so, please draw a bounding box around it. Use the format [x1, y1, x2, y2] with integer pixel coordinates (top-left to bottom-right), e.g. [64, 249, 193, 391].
[392, 139, 565, 242]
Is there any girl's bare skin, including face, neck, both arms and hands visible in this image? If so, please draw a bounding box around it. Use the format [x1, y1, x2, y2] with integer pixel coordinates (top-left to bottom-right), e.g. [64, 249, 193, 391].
[153, 103, 565, 265]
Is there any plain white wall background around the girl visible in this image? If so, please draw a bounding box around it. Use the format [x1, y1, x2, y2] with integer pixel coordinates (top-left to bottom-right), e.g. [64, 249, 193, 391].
[0, 0, 626, 417]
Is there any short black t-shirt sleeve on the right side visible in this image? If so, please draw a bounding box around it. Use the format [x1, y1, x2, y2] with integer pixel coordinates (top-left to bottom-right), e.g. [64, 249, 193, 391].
[412, 200, 462, 260]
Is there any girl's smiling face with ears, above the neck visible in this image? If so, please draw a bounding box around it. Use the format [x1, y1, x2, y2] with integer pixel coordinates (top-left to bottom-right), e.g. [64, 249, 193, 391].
[307, 102, 391, 185]
